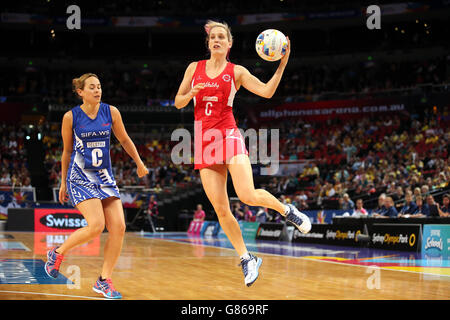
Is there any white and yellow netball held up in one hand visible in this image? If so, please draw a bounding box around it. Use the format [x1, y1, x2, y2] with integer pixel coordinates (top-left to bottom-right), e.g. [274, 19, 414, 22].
[255, 29, 287, 61]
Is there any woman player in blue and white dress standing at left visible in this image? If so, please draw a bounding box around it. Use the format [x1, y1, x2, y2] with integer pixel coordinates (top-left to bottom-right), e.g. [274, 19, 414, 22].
[45, 73, 148, 299]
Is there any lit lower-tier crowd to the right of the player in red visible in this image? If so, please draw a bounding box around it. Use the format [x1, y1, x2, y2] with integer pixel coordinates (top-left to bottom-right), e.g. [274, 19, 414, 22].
[264, 107, 450, 214]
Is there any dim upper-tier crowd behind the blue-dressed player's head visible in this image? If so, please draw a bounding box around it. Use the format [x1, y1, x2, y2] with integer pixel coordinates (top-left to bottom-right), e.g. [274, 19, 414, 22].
[0, 66, 183, 107]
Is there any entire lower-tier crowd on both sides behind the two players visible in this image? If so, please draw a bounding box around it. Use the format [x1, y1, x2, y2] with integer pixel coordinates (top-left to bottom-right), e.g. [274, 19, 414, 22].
[0, 102, 450, 215]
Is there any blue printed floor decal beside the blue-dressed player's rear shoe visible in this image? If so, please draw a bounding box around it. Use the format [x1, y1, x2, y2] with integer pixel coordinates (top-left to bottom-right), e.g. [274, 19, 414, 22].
[0, 259, 73, 284]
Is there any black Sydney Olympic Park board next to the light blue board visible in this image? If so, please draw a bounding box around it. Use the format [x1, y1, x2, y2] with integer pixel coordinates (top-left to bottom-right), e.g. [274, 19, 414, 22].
[369, 223, 422, 251]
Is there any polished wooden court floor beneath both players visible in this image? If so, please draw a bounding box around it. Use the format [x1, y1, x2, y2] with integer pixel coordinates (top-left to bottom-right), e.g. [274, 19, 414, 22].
[0, 232, 450, 300]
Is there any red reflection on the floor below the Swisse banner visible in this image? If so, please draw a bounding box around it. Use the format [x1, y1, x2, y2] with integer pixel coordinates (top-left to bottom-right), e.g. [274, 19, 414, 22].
[34, 232, 100, 256]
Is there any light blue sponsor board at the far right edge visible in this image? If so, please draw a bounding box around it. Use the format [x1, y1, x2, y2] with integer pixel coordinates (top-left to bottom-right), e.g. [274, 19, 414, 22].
[422, 224, 450, 257]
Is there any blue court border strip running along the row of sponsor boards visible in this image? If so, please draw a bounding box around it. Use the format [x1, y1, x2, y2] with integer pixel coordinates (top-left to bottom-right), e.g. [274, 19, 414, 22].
[138, 232, 450, 279]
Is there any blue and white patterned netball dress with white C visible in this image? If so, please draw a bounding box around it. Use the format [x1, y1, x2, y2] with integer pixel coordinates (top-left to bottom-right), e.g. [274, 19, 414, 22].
[67, 103, 120, 206]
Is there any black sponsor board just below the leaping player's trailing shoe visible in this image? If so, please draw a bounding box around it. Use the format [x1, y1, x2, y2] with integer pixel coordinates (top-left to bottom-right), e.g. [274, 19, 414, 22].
[292, 224, 363, 246]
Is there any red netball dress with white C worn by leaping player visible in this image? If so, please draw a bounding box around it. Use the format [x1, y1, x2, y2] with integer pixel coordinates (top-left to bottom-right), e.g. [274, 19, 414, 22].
[191, 60, 248, 169]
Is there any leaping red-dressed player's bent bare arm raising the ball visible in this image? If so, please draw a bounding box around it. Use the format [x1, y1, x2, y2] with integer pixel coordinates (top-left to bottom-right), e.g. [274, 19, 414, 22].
[235, 37, 291, 99]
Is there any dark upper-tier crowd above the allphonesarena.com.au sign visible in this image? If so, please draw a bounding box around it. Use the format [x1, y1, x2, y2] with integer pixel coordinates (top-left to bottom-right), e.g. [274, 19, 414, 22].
[276, 56, 450, 102]
